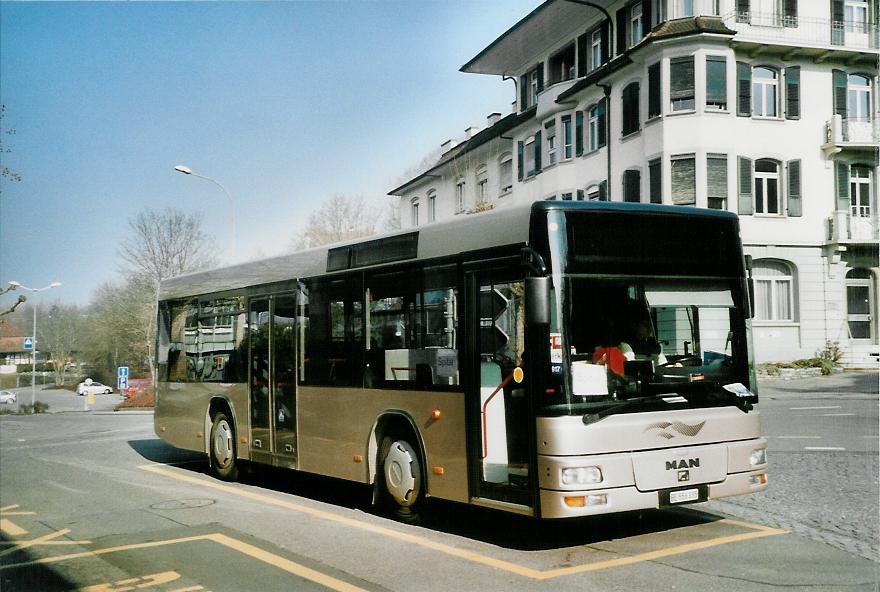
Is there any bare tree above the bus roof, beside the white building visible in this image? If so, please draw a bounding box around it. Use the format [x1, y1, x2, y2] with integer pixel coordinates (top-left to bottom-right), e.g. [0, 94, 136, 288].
[290, 194, 379, 251]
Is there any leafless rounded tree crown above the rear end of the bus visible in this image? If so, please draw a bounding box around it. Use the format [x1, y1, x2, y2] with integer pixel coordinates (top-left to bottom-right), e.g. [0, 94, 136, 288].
[119, 208, 216, 286]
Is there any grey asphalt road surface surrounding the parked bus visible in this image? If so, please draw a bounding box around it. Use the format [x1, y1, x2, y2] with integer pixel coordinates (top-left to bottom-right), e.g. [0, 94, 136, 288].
[0, 375, 880, 592]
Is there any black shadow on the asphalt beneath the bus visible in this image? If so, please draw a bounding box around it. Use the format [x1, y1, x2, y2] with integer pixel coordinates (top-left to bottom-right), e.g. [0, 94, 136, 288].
[129, 439, 721, 551]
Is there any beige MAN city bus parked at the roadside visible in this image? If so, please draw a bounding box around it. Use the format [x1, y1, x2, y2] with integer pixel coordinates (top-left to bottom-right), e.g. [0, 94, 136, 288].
[155, 201, 767, 521]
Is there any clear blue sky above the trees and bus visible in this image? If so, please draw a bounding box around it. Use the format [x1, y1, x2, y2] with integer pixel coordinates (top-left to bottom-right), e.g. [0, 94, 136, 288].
[0, 0, 540, 305]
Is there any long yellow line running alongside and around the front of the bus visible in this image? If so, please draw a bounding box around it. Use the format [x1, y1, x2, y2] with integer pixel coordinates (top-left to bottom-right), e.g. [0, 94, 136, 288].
[139, 465, 788, 580]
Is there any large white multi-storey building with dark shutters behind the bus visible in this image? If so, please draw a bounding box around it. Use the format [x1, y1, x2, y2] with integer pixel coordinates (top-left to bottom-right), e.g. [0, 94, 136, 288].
[390, 0, 880, 367]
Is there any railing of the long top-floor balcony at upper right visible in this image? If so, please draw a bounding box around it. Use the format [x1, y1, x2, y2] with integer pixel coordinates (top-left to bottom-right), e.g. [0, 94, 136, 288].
[721, 12, 880, 49]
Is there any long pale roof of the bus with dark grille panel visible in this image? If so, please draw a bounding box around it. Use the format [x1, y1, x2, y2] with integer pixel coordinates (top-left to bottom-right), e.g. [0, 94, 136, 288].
[159, 201, 738, 300]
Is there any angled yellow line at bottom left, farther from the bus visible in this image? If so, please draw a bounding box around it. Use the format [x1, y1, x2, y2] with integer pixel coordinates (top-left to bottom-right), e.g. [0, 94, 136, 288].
[0, 533, 366, 592]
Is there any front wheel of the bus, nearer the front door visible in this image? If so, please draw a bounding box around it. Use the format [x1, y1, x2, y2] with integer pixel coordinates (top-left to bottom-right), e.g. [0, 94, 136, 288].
[379, 437, 424, 524]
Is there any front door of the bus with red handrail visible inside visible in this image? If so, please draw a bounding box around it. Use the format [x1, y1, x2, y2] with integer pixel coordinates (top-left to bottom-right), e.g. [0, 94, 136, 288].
[468, 274, 534, 507]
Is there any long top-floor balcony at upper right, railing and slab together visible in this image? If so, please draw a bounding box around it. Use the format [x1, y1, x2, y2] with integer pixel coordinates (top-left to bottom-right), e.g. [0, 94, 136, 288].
[722, 12, 880, 64]
